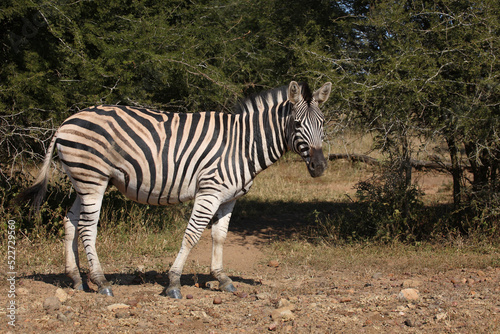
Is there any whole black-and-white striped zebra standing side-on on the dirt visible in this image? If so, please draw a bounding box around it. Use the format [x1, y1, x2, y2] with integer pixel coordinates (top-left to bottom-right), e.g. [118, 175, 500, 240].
[19, 81, 332, 299]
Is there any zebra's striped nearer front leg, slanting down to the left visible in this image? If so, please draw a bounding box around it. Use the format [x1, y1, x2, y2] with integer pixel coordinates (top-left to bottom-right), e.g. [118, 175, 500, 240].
[164, 195, 219, 299]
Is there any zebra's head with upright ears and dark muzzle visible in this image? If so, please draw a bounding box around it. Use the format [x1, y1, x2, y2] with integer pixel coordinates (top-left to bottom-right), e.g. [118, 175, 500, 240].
[288, 81, 332, 177]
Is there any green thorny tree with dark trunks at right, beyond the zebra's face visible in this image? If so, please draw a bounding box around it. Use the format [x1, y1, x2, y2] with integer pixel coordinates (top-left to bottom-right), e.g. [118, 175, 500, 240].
[348, 0, 500, 230]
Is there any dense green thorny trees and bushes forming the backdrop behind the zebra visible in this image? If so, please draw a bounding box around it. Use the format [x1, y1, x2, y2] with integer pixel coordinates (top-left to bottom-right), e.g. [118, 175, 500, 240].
[0, 0, 500, 240]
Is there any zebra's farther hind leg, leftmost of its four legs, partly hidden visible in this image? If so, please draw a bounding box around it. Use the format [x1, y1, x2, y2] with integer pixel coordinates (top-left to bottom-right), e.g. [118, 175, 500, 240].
[64, 197, 89, 290]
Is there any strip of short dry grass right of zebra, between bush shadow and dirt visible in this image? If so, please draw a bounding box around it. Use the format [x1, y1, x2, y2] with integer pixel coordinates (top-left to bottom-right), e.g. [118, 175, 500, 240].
[270, 239, 500, 274]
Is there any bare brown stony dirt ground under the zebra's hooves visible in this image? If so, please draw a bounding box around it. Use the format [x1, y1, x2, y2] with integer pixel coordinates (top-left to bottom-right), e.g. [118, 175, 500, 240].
[0, 219, 500, 333]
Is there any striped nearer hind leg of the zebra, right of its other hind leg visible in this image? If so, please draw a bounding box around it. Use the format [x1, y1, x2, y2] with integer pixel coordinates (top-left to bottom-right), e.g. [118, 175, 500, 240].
[78, 196, 113, 296]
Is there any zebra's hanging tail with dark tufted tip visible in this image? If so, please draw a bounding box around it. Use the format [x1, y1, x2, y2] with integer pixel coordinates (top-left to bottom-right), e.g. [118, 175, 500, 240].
[15, 134, 57, 213]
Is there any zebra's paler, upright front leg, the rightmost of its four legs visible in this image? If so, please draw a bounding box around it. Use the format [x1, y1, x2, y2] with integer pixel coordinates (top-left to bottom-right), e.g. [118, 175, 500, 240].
[210, 200, 236, 292]
